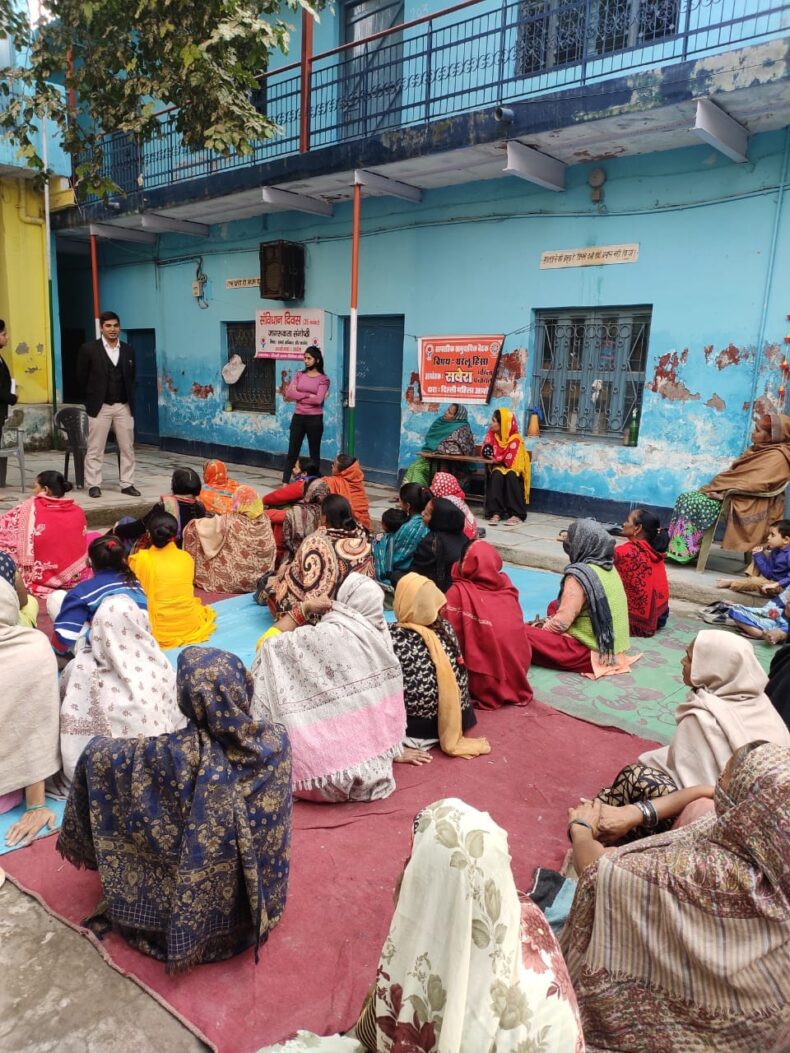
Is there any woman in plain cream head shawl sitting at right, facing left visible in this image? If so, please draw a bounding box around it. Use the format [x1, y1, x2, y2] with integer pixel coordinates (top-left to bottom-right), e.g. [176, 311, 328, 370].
[598, 629, 790, 840]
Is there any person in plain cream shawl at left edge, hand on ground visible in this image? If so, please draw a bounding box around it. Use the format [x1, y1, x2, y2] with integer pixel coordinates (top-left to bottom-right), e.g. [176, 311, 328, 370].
[0, 557, 60, 846]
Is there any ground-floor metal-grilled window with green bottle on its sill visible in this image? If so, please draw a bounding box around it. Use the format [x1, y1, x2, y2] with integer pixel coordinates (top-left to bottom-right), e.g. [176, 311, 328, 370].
[532, 306, 651, 441]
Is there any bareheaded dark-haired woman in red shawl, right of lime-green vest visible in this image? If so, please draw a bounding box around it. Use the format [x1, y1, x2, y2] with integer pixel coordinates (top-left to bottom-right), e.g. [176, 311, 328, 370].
[614, 509, 669, 636]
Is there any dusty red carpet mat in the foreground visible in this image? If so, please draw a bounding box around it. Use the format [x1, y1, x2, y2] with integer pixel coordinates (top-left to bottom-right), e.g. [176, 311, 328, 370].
[3, 702, 653, 1053]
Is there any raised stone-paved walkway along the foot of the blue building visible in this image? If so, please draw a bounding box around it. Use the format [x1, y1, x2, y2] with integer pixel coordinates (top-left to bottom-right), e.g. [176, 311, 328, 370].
[0, 446, 743, 604]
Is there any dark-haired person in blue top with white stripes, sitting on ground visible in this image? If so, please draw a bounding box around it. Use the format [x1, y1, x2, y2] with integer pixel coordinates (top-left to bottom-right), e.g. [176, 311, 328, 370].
[46, 534, 147, 654]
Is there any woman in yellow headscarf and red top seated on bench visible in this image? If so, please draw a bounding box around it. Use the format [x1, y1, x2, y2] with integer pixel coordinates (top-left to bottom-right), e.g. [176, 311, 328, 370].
[481, 409, 531, 527]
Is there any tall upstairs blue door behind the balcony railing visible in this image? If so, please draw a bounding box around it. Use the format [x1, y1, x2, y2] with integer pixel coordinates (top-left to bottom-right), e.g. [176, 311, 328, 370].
[342, 0, 403, 137]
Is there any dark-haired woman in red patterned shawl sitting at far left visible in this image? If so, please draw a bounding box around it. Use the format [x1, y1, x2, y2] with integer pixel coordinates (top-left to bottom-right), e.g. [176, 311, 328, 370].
[0, 472, 91, 596]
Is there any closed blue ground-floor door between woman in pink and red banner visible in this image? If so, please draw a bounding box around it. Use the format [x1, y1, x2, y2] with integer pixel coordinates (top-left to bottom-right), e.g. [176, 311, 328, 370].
[343, 315, 403, 485]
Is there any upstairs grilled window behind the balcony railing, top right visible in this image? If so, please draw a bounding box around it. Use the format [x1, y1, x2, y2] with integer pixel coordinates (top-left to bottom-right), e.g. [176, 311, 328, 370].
[516, 0, 679, 77]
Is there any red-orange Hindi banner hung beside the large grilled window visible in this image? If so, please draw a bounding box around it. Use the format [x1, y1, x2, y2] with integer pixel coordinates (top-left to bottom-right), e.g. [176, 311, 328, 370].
[419, 335, 505, 404]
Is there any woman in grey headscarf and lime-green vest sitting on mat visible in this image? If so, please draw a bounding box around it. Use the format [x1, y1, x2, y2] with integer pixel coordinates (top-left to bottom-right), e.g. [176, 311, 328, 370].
[525, 519, 636, 679]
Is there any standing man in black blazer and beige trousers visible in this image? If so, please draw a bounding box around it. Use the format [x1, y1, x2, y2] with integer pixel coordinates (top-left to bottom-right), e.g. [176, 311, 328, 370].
[77, 311, 140, 497]
